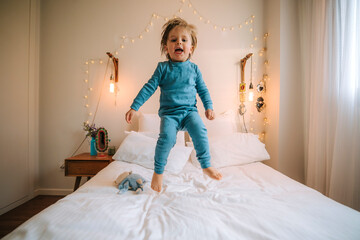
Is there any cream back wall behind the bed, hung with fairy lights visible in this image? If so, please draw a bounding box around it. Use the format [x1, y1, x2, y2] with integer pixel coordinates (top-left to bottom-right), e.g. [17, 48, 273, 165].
[39, 0, 263, 193]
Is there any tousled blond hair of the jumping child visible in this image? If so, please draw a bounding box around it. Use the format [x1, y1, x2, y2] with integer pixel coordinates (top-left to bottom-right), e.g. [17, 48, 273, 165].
[160, 17, 197, 60]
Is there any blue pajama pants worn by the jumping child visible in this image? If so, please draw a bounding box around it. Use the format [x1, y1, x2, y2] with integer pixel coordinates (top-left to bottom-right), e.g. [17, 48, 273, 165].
[154, 111, 211, 174]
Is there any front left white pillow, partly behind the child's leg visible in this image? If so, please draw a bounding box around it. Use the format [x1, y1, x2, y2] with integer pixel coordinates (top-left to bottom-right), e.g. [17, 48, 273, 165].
[113, 132, 192, 174]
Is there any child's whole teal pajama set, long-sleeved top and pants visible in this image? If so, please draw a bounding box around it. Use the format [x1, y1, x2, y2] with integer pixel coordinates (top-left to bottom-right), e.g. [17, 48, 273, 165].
[131, 60, 213, 174]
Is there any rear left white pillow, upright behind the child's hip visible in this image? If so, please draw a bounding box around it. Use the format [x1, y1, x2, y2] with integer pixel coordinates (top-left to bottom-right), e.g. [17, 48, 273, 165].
[139, 112, 185, 146]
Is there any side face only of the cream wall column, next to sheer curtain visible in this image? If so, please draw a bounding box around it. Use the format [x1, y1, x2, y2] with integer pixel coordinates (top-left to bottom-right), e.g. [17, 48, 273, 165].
[279, 0, 305, 183]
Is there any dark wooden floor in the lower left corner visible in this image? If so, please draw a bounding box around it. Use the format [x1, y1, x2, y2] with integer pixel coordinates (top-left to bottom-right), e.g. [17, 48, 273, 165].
[0, 195, 64, 238]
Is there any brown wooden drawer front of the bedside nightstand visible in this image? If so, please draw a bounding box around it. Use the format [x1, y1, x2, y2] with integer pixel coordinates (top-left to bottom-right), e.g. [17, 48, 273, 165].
[65, 160, 109, 176]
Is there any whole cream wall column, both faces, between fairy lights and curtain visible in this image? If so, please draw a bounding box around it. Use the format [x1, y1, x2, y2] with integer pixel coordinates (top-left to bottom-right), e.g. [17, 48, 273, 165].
[264, 0, 304, 183]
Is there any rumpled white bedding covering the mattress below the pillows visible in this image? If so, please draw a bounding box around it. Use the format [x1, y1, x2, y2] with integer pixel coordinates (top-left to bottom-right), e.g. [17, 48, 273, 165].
[4, 161, 360, 240]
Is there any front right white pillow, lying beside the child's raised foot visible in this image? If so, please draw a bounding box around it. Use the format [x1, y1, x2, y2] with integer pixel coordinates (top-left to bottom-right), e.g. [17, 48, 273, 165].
[187, 133, 270, 168]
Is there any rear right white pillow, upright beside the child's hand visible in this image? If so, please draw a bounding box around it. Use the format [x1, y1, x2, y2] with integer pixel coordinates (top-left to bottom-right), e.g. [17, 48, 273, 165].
[202, 110, 237, 137]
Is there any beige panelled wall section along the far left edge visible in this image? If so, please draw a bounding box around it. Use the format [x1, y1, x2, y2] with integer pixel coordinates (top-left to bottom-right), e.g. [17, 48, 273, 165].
[0, 0, 39, 214]
